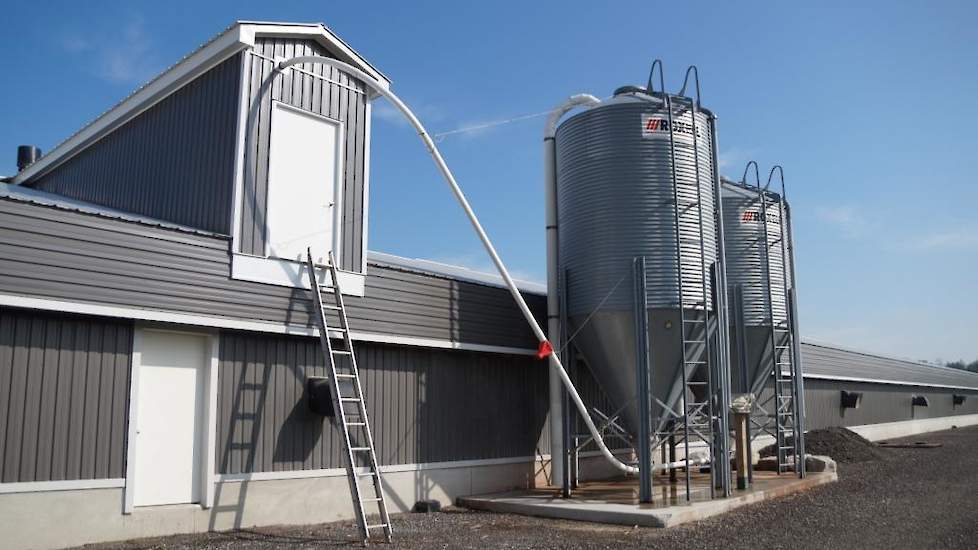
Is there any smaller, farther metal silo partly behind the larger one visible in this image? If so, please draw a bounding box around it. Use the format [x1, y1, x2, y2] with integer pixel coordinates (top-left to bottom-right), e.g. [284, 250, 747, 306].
[721, 180, 790, 395]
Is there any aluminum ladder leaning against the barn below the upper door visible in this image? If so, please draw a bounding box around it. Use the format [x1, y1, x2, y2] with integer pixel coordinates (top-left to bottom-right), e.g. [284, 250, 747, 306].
[306, 249, 393, 543]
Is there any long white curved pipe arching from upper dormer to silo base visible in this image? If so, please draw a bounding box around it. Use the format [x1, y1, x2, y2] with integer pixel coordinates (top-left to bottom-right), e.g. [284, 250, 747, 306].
[276, 55, 638, 474]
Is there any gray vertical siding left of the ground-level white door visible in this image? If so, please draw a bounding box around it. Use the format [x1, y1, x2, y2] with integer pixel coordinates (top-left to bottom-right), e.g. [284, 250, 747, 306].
[0, 308, 132, 483]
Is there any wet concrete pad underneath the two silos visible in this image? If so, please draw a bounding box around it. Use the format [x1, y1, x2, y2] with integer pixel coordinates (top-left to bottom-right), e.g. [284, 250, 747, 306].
[457, 472, 838, 527]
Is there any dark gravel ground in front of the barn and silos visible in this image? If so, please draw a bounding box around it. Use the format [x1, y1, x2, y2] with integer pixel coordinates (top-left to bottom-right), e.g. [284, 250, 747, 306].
[74, 427, 978, 550]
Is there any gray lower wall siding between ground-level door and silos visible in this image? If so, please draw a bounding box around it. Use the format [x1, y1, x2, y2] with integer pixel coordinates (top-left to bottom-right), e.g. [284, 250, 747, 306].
[217, 331, 547, 474]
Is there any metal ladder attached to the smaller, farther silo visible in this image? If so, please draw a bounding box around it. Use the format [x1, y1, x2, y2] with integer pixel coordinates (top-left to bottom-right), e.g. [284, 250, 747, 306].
[752, 179, 803, 474]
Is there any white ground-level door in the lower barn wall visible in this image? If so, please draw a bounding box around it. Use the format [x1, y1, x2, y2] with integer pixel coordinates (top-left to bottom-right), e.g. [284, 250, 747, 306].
[133, 330, 208, 506]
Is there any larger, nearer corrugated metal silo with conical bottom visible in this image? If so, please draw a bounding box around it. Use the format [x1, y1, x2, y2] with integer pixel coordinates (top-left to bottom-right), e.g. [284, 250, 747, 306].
[555, 87, 717, 440]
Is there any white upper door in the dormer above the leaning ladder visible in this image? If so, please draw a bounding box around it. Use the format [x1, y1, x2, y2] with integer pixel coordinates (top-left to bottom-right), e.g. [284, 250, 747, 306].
[266, 102, 342, 266]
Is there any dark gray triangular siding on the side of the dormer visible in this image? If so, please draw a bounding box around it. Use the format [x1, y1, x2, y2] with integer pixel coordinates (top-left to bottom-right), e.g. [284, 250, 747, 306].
[26, 55, 241, 234]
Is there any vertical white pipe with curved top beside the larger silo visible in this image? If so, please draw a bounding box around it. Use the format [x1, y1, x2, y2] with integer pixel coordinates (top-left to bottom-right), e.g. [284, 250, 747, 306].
[543, 94, 601, 485]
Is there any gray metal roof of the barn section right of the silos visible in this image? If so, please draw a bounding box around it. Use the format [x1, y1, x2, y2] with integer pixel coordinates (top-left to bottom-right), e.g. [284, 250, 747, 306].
[801, 342, 978, 390]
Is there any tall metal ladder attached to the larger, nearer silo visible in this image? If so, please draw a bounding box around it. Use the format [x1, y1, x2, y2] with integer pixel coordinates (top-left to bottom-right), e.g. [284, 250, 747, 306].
[648, 59, 726, 501]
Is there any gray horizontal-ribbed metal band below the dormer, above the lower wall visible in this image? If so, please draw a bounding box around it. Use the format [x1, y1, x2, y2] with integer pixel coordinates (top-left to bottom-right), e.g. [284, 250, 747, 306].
[0, 199, 544, 349]
